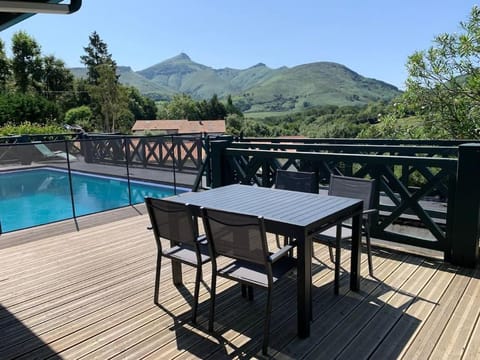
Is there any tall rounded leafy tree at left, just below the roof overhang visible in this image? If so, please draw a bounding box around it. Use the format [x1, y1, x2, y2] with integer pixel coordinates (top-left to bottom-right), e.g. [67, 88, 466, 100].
[12, 31, 42, 93]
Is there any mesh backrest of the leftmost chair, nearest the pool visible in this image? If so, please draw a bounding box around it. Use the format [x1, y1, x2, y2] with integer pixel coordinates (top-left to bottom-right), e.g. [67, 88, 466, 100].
[145, 197, 198, 245]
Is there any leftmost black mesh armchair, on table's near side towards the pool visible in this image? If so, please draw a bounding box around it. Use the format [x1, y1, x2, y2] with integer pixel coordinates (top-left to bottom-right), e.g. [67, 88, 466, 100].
[145, 197, 210, 323]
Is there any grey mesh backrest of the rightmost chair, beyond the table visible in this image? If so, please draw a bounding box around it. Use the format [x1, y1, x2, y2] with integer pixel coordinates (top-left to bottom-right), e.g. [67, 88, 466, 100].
[328, 175, 375, 210]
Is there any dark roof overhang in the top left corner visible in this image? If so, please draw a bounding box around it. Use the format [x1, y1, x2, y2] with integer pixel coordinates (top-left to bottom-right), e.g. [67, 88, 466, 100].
[0, 0, 82, 31]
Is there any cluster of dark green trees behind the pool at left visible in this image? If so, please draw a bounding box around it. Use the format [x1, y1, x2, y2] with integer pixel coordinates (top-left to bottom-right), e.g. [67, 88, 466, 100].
[0, 31, 157, 132]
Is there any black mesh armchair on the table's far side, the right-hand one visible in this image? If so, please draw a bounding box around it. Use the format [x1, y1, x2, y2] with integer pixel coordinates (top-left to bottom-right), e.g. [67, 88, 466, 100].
[313, 175, 378, 293]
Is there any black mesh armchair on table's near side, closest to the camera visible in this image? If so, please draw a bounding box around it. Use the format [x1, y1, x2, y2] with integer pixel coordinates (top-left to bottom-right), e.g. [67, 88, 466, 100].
[202, 208, 296, 354]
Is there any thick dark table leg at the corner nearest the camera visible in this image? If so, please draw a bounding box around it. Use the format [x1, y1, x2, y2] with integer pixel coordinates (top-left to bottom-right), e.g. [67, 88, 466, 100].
[297, 234, 312, 338]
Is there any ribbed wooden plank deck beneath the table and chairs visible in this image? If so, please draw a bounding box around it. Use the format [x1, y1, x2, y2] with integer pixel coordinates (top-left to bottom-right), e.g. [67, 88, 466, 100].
[0, 207, 480, 360]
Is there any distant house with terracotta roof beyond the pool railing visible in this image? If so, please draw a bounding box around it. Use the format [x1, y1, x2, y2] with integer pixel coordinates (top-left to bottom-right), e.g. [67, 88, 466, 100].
[132, 120, 225, 135]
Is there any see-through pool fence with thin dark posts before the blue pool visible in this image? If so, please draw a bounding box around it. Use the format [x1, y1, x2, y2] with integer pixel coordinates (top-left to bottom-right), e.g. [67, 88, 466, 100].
[0, 134, 205, 232]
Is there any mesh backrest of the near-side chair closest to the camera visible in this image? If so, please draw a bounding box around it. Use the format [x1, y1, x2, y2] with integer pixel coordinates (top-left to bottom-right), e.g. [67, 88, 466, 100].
[202, 208, 268, 265]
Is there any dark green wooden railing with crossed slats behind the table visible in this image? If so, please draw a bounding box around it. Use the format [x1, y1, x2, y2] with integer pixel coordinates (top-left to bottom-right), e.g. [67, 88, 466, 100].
[211, 138, 480, 266]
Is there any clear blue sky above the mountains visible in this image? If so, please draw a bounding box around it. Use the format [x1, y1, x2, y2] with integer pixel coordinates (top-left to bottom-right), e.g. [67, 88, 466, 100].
[0, 0, 478, 88]
